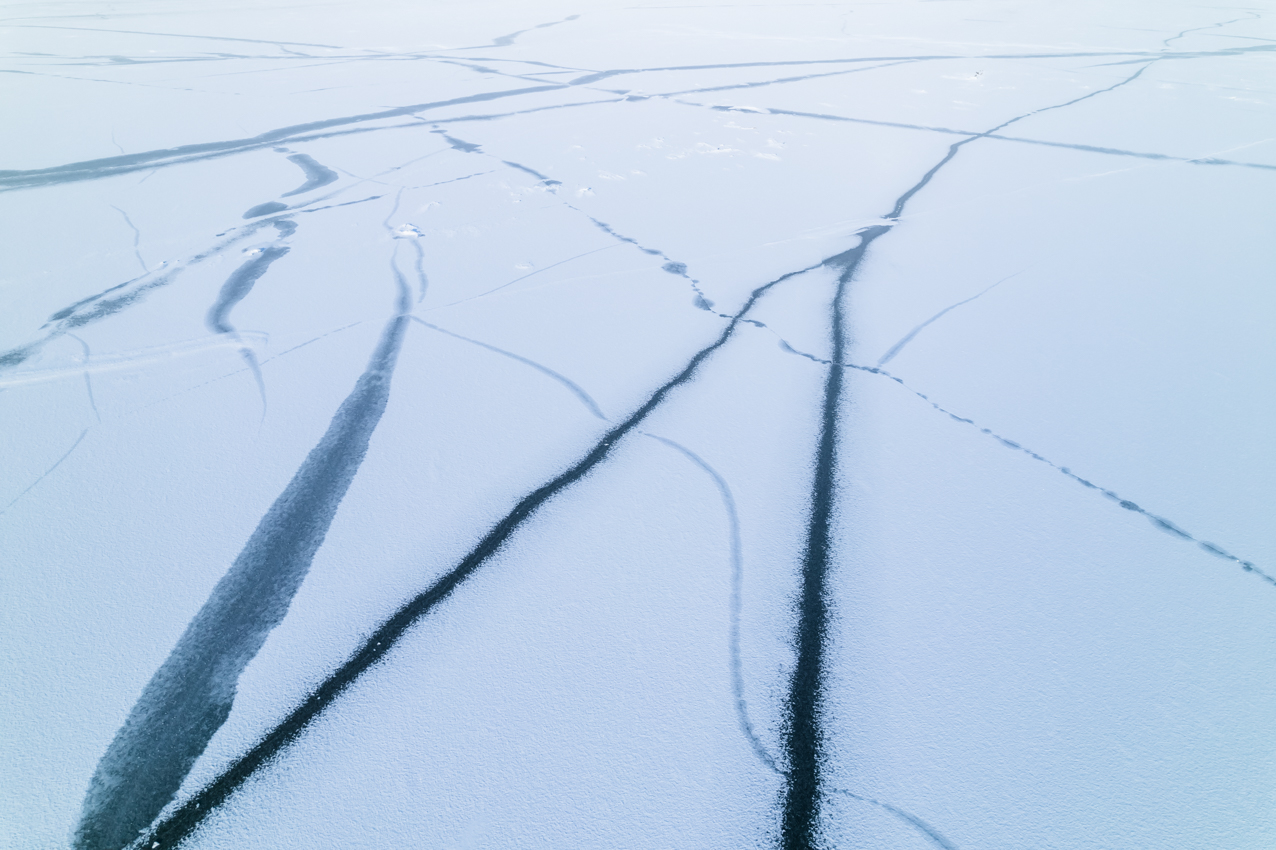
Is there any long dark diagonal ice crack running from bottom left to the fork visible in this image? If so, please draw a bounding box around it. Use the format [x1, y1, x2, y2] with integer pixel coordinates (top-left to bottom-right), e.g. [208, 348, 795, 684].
[132, 256, 823, 850]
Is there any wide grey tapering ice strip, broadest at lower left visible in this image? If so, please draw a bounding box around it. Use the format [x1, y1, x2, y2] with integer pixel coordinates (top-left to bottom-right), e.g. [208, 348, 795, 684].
[75, 269, 408, 850]
